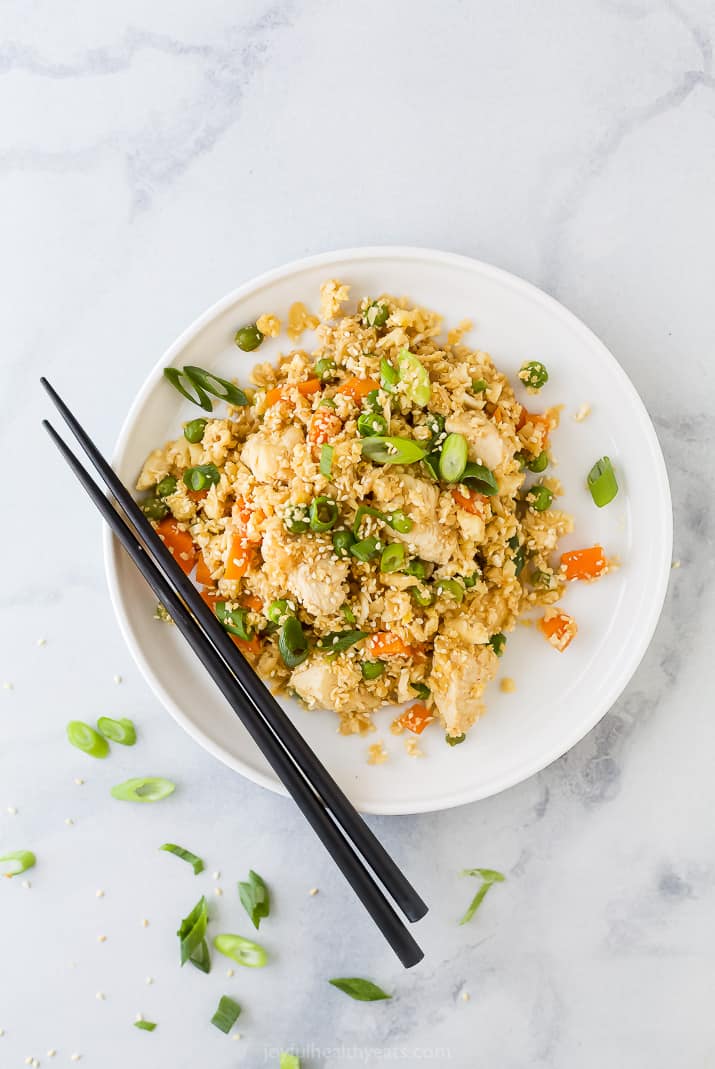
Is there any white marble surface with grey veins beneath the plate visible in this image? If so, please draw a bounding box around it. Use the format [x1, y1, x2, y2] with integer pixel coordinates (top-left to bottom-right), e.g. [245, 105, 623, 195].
[0, 0, 715, 1069]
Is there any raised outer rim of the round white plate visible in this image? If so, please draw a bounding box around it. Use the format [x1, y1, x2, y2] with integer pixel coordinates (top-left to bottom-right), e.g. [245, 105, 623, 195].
[103, 245, 673, 816]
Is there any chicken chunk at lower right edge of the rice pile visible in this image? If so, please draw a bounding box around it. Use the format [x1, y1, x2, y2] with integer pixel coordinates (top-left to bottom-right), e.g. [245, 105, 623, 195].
[428, 635, 498, 735]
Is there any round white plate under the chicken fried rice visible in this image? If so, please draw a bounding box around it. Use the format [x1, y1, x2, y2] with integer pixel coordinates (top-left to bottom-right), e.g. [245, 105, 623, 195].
[105, 248, 672, 814]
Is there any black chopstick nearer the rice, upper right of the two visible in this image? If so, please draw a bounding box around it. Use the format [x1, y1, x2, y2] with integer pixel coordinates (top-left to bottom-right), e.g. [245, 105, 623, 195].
[40, 377, 428, 920]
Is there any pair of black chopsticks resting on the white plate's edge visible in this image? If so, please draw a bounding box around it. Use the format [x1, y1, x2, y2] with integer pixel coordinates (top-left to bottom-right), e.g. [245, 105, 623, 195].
[41, 377, 428, 969]
